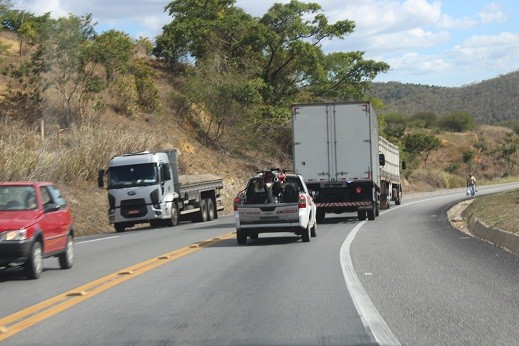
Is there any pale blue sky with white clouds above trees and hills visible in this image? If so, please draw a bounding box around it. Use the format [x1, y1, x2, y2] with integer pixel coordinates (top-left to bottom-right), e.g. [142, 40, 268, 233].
[13, 0, 519, 87]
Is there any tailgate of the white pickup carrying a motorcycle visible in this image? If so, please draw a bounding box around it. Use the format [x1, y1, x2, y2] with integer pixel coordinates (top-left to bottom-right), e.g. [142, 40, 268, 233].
[238, 203, 299, 227]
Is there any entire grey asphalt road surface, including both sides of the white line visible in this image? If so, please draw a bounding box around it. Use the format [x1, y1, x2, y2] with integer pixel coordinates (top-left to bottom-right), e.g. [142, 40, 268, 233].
[0, 185, 519, 345]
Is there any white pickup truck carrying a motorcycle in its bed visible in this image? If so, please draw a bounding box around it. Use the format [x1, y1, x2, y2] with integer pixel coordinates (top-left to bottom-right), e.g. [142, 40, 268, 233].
[234, 170, 317, 244]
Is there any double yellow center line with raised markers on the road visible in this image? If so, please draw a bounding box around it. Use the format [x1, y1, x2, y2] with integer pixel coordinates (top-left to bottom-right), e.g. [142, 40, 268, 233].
[0, 232, 236, 341]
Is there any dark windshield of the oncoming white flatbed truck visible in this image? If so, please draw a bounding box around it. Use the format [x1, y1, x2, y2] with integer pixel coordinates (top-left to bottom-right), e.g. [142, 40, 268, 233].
[108, 163, 158, 189]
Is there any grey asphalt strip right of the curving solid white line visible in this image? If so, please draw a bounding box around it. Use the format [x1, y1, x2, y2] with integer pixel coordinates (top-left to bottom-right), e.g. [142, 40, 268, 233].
[352, 184, 519, 345]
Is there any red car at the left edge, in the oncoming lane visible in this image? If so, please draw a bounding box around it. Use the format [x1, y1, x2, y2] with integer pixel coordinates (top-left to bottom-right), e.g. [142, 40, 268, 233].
[0, 182, 74, 279]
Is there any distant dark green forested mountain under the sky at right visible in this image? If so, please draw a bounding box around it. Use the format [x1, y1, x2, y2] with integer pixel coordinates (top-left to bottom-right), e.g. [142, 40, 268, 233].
[370, 71, 519, 124]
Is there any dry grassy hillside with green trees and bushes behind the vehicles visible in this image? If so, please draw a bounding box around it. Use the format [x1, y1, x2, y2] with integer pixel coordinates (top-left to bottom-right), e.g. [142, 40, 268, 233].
[0, 0, 519, 235]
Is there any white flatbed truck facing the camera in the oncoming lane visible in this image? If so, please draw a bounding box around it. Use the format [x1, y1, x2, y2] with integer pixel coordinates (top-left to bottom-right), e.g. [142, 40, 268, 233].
[98, 149, 223, 232]
